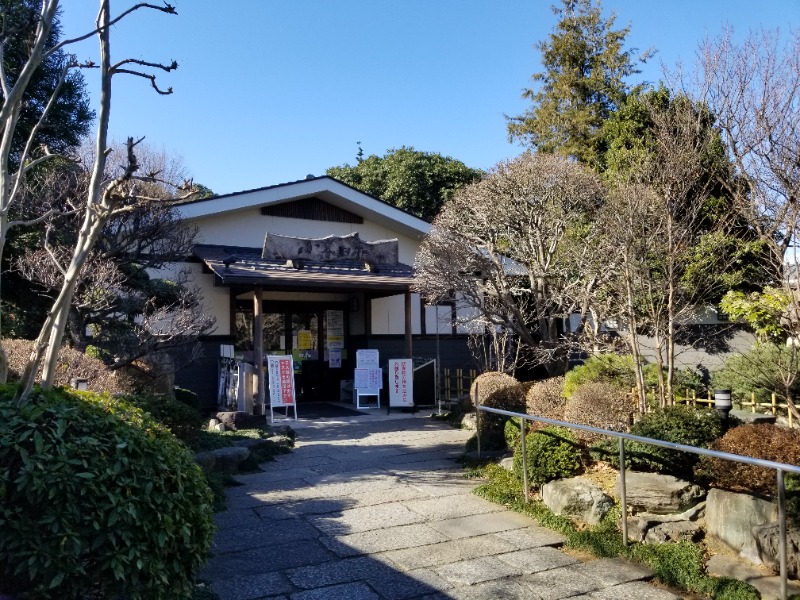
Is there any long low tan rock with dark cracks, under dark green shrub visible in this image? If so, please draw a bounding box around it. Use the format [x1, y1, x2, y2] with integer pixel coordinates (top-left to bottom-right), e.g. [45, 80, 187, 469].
[614, 471, 705, 515]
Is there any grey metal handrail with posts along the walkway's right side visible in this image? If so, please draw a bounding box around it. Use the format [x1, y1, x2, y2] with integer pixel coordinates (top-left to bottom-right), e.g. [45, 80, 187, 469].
[474, 398, 800, 600]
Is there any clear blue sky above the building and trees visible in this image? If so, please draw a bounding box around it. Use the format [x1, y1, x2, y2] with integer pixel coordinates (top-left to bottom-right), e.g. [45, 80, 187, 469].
[62, 0, 800, 194]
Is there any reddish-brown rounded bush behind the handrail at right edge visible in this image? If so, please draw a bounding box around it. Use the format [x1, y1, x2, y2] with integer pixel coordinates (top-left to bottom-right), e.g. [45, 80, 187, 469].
[701, 423, 800, 497]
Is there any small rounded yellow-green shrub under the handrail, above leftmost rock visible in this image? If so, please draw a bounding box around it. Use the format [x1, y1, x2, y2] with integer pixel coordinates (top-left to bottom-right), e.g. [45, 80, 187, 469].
[514, 427, 581, 486]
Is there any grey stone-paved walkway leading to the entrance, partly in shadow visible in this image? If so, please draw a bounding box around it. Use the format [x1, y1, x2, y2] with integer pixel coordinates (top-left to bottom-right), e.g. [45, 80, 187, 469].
[201, 413, 677, 600]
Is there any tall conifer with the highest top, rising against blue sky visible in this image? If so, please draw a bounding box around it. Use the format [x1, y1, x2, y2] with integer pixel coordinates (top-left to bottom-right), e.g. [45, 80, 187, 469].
[508, 0, 652, 164]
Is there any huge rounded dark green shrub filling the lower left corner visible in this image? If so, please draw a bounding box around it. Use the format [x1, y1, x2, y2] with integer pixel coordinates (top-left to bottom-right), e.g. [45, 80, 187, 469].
[0, 386, 213, 600]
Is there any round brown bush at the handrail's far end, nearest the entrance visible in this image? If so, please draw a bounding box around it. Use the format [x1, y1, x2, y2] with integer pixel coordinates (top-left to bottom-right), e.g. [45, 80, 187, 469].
[469, 373, 525, 450]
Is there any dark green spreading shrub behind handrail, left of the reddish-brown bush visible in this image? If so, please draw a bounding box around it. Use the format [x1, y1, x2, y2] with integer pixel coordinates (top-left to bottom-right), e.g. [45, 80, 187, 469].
[591, 406, 722, 479]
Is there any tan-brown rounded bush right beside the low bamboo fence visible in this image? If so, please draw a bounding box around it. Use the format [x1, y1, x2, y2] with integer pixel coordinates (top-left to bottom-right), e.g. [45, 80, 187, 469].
[564, 382, 636, 442]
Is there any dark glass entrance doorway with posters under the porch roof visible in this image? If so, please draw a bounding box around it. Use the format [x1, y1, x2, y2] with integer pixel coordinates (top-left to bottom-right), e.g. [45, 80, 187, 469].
[236, 301, 352, 402]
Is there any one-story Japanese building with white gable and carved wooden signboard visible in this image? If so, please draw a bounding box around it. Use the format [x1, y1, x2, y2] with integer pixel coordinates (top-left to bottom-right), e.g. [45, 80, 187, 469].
[171, 176, 473, 411]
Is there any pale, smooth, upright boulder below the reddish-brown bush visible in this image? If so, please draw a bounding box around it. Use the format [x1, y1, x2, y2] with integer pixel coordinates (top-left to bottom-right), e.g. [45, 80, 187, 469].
[706, 489, 778, 564]
